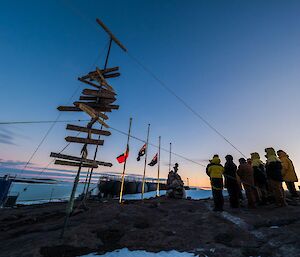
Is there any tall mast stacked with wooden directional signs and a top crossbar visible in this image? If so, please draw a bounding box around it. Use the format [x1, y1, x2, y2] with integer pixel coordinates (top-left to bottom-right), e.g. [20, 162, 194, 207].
[50, 19, 127, 237]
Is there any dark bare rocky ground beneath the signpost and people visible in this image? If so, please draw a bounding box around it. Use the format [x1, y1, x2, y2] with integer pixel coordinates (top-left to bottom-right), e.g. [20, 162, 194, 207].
[0, 197, 300, 257]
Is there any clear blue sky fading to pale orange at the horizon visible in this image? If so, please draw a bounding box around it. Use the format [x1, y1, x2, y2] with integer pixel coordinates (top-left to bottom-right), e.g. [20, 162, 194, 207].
[0, 0, 300, 186]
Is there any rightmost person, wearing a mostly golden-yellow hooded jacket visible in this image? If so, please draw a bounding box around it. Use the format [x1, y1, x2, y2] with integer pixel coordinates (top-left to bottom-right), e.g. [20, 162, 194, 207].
[277, 150, 299, 197]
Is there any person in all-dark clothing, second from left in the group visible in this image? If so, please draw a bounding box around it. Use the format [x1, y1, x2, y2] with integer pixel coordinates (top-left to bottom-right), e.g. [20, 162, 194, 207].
[224, 155, 240, 208]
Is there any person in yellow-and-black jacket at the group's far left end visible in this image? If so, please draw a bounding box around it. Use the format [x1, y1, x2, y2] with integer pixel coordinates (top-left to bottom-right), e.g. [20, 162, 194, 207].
[206, 154, 224, 211]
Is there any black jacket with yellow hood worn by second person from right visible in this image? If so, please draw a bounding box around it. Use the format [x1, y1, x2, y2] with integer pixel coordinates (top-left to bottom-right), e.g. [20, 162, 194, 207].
[265, 148, 283, 182]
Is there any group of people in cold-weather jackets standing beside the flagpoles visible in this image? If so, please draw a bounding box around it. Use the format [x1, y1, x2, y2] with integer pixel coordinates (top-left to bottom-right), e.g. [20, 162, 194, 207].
[206, 147, 299, 211]
